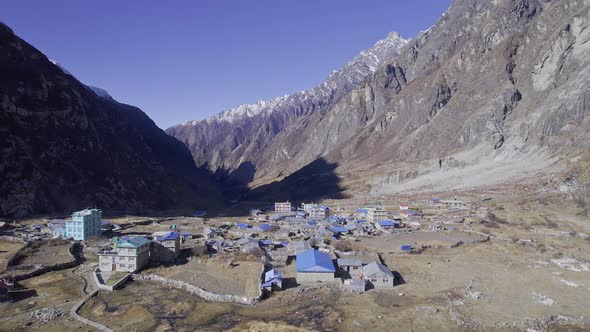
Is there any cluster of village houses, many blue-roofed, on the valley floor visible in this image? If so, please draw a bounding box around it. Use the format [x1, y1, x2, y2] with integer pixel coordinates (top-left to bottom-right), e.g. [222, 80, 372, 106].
[2, 199, 478, 300]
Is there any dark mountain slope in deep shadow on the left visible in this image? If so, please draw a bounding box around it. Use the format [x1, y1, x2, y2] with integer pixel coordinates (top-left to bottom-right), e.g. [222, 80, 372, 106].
[0, 24, 221, 217]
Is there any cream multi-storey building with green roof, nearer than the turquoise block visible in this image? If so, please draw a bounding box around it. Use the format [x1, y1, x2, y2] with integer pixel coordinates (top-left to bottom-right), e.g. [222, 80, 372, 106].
[98, 236, 151, 272]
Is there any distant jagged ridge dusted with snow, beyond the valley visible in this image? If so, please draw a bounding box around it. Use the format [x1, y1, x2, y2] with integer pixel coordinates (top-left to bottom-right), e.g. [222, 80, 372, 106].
[166, 33, 408, 183]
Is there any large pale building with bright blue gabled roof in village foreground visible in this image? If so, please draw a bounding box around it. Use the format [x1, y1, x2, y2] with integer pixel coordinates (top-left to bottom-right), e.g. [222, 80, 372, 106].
[296, 249, 336, 284]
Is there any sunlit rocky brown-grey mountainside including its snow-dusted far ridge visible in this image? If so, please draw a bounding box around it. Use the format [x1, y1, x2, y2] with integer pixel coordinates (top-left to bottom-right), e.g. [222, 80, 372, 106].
[167, 0, 590, 196]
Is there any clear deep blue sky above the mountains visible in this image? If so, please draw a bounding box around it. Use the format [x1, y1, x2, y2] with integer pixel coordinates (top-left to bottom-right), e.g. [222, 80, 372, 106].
[0, 0, 452, 128]
